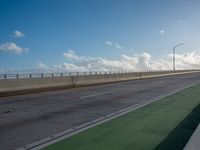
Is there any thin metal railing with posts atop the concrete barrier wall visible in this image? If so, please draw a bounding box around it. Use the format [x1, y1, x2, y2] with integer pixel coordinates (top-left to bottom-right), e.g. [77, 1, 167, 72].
[0, 70, 197, 80]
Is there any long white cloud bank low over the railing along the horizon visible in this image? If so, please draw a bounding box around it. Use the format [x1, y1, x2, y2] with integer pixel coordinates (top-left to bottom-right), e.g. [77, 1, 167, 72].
[0, 50, 200, 73]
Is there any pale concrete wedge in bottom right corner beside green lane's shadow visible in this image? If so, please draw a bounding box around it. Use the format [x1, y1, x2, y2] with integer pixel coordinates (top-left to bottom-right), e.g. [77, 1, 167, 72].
[184, 124, 200, 150]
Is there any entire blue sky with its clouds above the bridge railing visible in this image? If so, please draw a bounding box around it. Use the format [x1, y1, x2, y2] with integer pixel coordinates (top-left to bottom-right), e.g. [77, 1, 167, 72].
[0, 0, 200, 73]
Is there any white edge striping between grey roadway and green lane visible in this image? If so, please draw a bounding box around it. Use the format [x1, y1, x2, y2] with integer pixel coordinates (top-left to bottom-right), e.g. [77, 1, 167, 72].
[17, 82, 200, 150]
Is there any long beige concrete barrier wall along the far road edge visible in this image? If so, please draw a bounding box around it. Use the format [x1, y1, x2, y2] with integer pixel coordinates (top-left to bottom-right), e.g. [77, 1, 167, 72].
[0, 70, 197, 94]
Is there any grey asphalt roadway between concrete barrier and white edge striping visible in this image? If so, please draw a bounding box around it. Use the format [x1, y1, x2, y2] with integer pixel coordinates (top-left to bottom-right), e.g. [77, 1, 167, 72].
[0, 73, 200, 150]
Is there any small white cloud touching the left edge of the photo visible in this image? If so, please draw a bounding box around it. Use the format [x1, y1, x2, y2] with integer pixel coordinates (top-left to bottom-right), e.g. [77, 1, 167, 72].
[0, 42, 29, 54]
